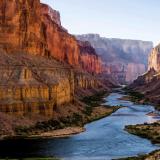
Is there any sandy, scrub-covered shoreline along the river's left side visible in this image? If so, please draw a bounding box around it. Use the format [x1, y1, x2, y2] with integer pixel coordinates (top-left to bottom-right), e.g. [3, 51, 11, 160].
[0, 90, 122, 141]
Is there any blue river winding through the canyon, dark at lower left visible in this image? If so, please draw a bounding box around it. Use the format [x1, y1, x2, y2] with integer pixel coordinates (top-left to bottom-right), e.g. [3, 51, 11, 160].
[0, 92, 160, 160]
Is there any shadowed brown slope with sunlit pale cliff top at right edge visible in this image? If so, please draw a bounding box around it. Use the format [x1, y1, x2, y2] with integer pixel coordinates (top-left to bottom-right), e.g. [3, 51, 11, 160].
[129, 45, 160, 105]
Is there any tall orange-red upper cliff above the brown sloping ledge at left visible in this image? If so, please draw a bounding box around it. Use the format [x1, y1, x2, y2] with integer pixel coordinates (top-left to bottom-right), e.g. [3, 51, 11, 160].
[0, 0, 102, 72]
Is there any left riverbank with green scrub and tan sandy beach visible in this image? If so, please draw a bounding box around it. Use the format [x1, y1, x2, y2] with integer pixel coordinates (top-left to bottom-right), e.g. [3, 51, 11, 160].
[0, 91, 121, 140]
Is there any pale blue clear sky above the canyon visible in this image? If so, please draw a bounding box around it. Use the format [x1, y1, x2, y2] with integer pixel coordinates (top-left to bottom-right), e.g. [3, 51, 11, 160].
[41, 0, 160, 45]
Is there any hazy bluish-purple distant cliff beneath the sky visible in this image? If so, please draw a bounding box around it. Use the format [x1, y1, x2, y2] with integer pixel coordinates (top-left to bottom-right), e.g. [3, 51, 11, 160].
[76, 34, 153, 83]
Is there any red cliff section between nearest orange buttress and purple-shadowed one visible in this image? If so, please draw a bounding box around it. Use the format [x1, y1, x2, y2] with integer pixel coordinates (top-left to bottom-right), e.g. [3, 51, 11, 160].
[41, 5, 80, 66]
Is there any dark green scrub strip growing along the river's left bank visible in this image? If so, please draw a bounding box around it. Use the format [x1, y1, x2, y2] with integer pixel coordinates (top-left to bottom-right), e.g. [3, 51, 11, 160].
[15, 91, 117, 137]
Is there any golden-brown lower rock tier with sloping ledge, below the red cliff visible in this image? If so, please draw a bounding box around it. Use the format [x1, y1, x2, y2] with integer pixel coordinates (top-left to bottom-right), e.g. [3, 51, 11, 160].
[0, 53, 74, 116]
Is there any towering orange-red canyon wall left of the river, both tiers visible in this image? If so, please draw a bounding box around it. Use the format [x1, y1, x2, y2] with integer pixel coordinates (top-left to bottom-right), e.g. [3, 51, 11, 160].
[0, 0, 107, 116]
